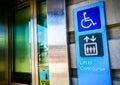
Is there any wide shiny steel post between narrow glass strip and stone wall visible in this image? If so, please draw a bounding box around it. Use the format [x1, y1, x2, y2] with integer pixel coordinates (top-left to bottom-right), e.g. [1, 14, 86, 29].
[46, 0, 70, 85]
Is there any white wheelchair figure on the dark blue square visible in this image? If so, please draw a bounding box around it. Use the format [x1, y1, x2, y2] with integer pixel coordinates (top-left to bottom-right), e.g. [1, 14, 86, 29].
[81, 12, 97, 28]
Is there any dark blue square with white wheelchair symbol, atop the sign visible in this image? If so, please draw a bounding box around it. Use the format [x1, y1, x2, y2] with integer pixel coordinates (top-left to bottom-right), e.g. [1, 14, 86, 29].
[77, 7, 101, 32]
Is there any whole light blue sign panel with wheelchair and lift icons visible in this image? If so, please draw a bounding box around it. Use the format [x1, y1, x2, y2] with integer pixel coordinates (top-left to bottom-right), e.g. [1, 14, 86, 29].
[73, 2, 111, 85]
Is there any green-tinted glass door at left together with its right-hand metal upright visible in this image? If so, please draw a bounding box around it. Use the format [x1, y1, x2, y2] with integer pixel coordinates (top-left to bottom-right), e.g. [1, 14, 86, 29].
[11, 0, 38, 85]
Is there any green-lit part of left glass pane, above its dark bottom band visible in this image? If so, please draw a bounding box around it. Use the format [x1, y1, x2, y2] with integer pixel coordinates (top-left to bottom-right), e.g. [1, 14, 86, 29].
[14, 7, 31, 72]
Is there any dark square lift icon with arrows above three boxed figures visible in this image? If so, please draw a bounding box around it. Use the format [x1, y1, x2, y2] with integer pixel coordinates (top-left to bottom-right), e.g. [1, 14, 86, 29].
[79, 33, 103, 57]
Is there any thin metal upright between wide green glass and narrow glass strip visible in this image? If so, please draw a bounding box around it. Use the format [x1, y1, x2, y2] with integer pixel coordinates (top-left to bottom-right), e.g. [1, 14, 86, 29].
[30, 0, 38, 85]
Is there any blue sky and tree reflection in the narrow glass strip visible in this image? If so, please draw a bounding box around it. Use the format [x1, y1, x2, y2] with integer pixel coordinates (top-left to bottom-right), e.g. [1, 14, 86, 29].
[37, 25, 48, 66]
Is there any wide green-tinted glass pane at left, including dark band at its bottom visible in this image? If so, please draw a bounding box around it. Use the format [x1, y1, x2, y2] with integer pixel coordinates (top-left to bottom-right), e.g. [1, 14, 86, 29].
[12, 7, 31, 84]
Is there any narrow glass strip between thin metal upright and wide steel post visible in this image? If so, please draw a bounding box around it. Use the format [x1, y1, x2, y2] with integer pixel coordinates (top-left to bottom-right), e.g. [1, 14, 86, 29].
[37, 0, 49, 85]
